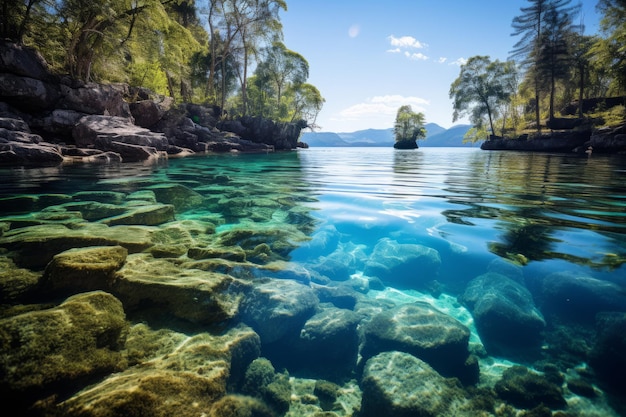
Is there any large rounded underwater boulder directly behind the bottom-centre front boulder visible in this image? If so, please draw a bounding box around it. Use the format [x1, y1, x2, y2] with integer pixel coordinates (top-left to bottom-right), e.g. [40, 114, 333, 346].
[361, 302, 478, 383]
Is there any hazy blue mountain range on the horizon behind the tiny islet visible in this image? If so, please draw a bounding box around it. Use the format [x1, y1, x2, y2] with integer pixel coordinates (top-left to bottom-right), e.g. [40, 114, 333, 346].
[300, 123, 480, 147]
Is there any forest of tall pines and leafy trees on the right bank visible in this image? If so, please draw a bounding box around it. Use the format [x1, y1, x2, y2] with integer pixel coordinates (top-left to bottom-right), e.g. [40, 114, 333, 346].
[449, 0, 626, 140]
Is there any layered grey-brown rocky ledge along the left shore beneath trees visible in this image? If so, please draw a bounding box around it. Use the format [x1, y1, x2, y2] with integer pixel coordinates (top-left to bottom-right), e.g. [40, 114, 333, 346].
[0, 41, 306, 166]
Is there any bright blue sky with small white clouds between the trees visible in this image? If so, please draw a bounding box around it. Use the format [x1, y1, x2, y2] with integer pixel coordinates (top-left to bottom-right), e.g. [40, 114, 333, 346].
[281, 0, 598, 132]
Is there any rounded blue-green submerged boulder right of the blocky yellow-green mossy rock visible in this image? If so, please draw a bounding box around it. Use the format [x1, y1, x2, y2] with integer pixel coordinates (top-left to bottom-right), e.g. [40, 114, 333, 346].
[241, 279, 319, 344]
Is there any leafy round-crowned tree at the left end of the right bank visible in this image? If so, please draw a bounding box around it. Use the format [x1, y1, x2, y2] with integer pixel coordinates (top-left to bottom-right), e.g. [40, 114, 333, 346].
[450, 55, 516, 135]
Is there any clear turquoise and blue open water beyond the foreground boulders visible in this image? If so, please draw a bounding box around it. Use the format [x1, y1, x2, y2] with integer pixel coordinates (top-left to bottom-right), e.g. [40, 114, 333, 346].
[0, 148, 626, 412]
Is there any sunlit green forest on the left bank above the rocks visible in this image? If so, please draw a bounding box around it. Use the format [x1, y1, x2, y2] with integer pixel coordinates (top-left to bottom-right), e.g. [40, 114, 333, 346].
[0, 0, 324, 125]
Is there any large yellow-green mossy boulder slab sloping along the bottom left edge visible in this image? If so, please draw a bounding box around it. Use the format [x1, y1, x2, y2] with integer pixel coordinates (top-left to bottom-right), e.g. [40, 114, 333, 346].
[57, 326, 260, 417]
